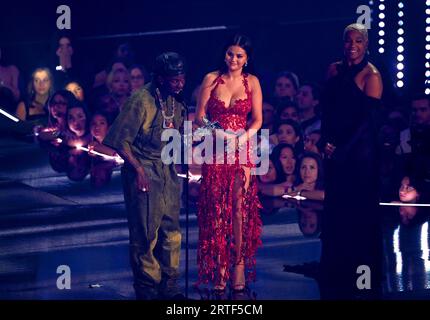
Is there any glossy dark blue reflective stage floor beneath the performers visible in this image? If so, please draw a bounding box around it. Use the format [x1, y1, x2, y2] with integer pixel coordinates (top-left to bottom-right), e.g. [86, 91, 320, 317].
[0, 139, 430, 300]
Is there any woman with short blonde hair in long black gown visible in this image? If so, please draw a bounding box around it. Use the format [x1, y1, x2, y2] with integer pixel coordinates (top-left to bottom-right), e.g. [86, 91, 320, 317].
[320, 24, 382, 299]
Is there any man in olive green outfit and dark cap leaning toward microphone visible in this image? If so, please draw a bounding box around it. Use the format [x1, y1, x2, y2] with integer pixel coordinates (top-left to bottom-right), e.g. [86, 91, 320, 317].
[103, 52, 185, 300]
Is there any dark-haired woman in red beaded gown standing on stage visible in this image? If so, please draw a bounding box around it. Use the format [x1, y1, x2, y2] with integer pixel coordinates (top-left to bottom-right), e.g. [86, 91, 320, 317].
[196, 35, 262, 291]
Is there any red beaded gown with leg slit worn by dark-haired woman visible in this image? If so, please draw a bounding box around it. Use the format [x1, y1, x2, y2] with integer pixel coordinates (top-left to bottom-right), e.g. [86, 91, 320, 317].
[196, 74, 262, 285]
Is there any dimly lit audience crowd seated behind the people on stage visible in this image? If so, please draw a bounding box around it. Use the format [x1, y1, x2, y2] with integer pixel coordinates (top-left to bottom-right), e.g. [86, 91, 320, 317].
[0, 34, 430, 210]
